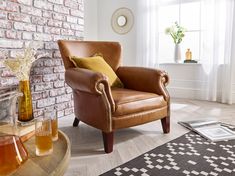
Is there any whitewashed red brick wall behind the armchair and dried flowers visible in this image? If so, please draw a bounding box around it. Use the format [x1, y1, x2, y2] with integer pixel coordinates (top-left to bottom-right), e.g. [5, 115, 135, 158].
[0, 0, 84, 117]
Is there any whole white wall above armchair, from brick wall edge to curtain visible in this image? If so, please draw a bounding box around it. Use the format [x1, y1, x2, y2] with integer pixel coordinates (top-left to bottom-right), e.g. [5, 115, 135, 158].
[84, 0, 136, 65]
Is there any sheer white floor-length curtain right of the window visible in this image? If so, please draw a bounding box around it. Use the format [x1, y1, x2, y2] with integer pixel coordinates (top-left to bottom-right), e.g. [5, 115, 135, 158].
[200, 0, 235, 104]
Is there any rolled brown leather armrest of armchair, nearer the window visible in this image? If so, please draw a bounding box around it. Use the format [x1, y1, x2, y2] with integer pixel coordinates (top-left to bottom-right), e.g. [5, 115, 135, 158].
[116, 67, 170, 101]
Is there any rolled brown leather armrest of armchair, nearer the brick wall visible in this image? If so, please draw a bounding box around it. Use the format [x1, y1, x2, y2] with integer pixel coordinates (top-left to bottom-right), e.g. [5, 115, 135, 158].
[65, 68, 115, 112]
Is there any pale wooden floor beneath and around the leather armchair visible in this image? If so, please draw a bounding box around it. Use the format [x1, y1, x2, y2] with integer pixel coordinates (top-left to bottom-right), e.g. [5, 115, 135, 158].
[59, 99, 235, 176]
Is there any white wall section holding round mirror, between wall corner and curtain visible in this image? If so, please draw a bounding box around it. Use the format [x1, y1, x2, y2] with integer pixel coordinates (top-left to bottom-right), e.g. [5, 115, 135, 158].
[98, 0, 136, 65]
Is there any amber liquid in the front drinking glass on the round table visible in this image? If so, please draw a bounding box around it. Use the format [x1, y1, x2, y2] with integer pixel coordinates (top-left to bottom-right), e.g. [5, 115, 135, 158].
[35, 131, 53, 156]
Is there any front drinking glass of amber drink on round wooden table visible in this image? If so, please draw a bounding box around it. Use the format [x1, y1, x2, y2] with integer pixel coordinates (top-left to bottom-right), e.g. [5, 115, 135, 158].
[35, 117, 53, 156]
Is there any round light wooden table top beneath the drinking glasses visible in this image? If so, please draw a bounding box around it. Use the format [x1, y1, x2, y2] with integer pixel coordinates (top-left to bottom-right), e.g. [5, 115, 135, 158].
[11, 130, 71, 176]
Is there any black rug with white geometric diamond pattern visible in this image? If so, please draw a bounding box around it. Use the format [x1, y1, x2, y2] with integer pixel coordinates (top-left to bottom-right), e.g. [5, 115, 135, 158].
[102, 131, 235, 176]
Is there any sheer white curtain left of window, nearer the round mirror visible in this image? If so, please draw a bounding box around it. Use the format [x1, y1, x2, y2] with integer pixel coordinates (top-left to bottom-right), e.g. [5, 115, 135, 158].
[136, 0, 158, 68]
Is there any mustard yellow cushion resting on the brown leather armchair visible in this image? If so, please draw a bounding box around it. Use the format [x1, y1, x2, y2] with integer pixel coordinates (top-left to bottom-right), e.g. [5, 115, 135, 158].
[70, 56, 124, 87]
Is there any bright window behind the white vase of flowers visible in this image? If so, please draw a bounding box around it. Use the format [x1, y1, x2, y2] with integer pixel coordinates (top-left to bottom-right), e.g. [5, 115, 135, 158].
[158, 0, 201, 63]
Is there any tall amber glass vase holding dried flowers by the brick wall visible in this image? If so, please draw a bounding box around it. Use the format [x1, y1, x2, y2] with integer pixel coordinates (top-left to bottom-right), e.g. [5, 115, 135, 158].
[18, 80, 33, 122]
